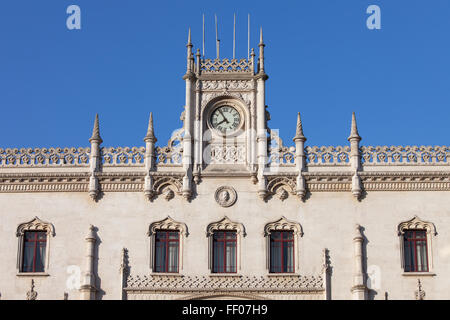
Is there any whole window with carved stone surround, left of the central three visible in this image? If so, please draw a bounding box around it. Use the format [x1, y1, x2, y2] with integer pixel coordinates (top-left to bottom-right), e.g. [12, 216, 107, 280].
[148, 216, 189, 273]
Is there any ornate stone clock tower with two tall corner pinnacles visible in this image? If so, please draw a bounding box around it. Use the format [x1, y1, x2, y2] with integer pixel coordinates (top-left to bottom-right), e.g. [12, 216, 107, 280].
[183, 29, 268, 196]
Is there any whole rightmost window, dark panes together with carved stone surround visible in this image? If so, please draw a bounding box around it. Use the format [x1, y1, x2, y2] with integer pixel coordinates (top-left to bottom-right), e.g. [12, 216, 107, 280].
[397, 216, 437, 275]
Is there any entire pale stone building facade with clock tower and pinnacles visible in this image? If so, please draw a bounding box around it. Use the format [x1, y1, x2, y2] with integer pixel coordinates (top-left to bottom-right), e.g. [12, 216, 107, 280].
[0, 31, 450, 300]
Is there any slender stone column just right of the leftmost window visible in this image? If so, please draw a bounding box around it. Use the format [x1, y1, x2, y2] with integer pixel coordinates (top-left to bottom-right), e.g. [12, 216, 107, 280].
[80, 225, 97, 300]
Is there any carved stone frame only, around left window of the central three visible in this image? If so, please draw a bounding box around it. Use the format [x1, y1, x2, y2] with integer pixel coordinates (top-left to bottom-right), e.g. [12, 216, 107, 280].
[147, 216, 189, 275]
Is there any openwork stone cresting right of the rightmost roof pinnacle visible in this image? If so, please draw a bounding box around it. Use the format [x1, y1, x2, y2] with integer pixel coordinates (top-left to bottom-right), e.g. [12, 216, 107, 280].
[361, 146, 450, 166]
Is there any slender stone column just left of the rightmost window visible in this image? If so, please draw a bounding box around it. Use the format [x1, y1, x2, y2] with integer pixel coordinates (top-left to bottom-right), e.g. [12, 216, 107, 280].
[351, 224, 367, 300]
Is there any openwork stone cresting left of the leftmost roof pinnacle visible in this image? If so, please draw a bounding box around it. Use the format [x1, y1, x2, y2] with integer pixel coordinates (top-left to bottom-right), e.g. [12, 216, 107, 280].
[0, 147, 91, 168]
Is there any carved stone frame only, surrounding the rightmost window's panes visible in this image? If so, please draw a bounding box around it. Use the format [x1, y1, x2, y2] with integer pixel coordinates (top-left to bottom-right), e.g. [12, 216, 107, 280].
[397, 216, 437, 276]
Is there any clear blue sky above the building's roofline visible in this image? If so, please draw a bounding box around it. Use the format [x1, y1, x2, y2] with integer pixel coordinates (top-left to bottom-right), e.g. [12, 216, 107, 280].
[0, 0, 450, 147]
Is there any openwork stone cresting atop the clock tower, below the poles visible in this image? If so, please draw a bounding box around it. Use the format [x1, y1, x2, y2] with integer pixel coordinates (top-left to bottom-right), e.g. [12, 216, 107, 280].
[200, 59, 254, 74]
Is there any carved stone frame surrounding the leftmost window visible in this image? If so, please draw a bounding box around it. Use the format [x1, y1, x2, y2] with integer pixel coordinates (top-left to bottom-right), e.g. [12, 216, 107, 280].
[16, 217, 55, 276]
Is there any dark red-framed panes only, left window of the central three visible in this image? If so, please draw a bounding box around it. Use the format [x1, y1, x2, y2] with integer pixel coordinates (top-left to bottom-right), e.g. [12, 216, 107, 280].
[154, 230, 180, 272]
